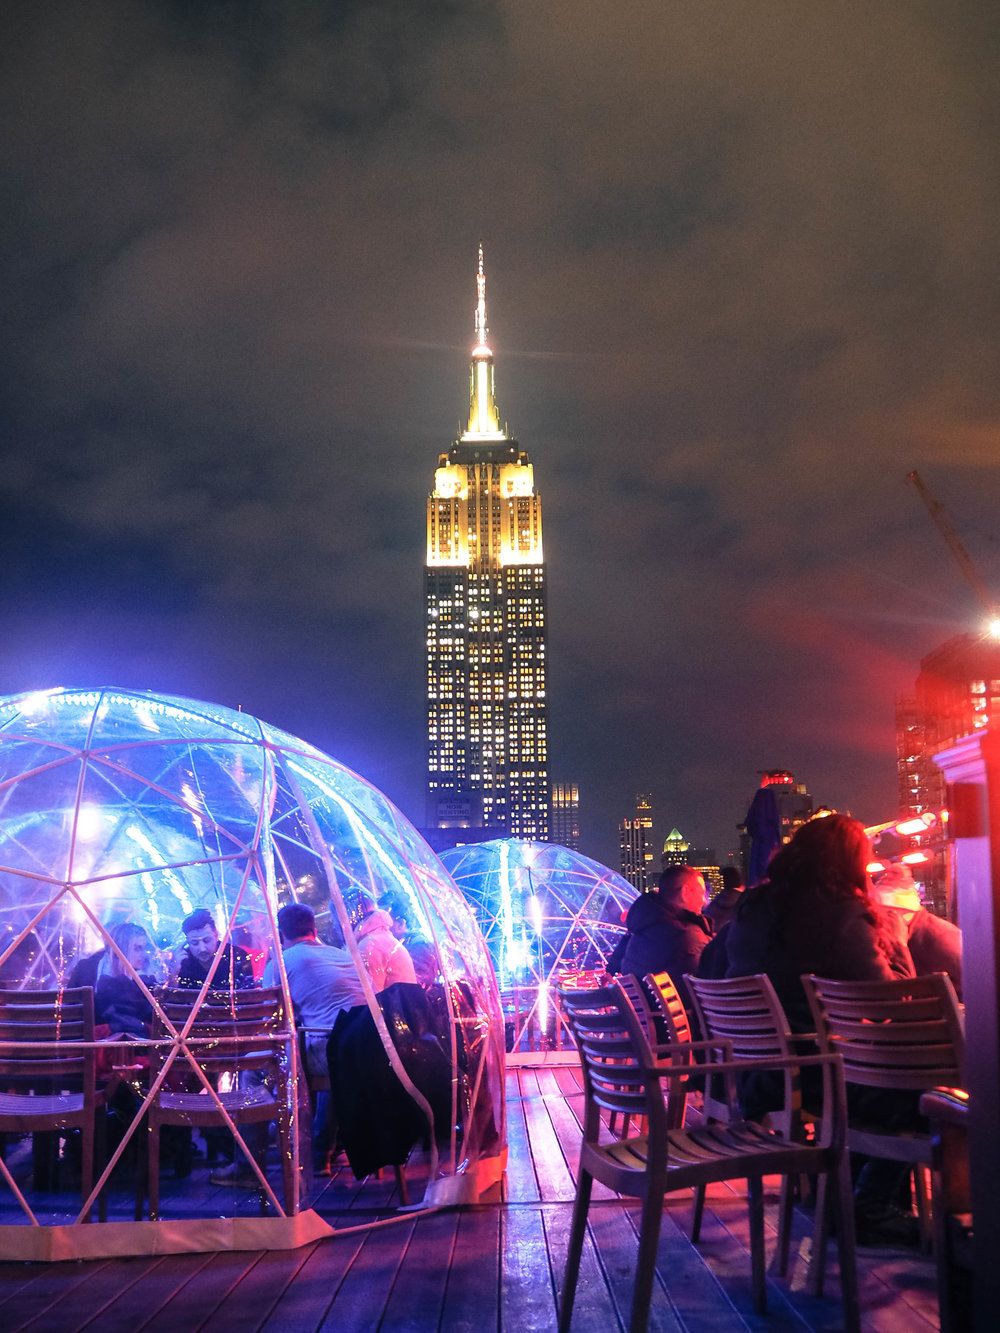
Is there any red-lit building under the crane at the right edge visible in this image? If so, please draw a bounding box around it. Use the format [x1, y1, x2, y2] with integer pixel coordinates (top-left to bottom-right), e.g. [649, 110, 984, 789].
[896, 635, 1000, 914]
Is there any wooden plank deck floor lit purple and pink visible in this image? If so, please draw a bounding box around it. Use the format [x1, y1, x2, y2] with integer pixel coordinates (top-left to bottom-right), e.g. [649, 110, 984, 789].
[0, 1066, 937, 1333]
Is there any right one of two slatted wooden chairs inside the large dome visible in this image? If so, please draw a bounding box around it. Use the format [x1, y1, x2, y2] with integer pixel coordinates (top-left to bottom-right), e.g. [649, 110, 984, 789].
[136, 988, 297, 1218]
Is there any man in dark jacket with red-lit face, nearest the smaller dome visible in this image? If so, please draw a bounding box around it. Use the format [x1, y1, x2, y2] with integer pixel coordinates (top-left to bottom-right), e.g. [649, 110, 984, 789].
[615, 865, 712, 1002]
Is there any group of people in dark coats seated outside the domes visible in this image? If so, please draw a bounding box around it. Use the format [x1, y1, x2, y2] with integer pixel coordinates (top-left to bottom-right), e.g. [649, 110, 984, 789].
[608, 814, 961, 1244]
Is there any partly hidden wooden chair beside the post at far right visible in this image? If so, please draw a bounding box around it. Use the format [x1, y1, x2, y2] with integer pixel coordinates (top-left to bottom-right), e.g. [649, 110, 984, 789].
[920, 1088, 973, 1333]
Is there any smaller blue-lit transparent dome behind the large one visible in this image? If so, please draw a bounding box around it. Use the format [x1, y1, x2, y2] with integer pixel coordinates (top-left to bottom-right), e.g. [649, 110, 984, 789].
[441, 838, 636, 1050]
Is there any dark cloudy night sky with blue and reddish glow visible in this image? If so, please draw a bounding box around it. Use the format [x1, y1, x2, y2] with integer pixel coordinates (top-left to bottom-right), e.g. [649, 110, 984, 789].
[0, 0, 1000, 858]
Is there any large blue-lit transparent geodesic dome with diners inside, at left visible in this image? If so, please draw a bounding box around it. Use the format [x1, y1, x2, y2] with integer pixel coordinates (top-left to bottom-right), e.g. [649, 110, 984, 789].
[0, 689, 504, 1257]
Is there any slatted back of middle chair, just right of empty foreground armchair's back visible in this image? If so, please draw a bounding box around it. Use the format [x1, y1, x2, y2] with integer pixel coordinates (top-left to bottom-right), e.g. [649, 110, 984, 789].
[685, 973, 801, 1134]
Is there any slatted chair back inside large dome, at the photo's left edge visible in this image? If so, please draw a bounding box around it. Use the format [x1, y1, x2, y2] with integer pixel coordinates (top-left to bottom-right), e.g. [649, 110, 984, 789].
[0, 986, 96, 1100]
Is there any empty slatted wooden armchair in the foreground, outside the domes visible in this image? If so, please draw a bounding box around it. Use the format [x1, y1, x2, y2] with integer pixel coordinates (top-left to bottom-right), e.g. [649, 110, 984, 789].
[559, 985, 859, 1333]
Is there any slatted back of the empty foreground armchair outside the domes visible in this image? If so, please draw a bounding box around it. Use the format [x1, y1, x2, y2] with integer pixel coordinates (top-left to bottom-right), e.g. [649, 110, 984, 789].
[560, 985, 667, 1144]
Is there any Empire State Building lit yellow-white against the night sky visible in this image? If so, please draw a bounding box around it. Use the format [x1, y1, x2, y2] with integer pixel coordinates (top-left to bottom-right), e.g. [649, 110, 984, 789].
[425, 245, 549, 841]
